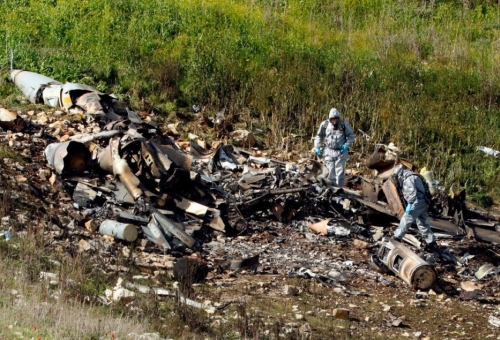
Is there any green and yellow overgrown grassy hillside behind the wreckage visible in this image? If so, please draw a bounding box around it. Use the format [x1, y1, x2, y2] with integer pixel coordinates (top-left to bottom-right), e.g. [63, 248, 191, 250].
[0, 0, 500, 201]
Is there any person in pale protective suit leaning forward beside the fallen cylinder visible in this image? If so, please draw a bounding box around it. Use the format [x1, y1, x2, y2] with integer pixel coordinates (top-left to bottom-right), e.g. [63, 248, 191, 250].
[393, 164, 439, 251]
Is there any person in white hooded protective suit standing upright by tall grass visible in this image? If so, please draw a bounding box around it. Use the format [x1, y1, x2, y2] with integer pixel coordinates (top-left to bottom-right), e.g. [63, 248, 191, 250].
[314, 108, 356, 187]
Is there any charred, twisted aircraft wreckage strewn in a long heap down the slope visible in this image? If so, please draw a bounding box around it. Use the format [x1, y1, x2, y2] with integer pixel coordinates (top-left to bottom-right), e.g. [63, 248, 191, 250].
[1, 70, 500, 289]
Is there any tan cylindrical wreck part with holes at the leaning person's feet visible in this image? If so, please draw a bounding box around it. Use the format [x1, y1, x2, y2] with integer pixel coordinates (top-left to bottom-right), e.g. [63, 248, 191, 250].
[372, 239, 437, 290]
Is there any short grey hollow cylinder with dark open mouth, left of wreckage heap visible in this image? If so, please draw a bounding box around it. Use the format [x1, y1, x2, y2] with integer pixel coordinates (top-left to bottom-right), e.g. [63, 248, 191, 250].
[45, 142, 91, 175]
